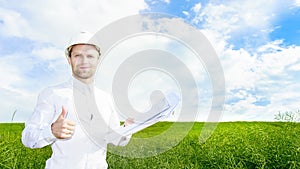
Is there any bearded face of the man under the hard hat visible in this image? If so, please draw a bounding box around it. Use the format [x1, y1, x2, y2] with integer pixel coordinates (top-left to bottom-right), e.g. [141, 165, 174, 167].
[68, 45, 100, 83]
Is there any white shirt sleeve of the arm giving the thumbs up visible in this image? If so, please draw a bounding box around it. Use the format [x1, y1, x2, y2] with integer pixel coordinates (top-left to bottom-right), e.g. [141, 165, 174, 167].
[22, 89, 56, 148]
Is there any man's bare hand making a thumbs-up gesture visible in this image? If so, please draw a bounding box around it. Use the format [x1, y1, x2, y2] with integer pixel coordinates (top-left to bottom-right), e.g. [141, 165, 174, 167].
[51, 106, 75, 139]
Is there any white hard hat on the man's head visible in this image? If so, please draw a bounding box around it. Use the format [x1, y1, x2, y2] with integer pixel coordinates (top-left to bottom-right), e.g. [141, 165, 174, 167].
[65, 31, 100, 57]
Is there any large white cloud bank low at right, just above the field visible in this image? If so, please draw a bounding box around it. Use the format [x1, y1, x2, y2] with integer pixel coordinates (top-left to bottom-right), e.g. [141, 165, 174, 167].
[221, 42, 300, 121]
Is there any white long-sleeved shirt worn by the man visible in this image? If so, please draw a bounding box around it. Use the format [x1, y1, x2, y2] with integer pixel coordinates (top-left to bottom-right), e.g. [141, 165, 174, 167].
[22, 78, 130, 169]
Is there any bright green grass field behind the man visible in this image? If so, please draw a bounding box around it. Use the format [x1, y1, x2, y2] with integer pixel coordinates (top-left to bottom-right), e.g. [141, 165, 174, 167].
[0, 122, 300, 169]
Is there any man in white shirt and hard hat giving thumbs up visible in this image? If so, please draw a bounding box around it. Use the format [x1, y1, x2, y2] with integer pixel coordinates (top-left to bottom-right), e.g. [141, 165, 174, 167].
[22, 32, 132, 169]
